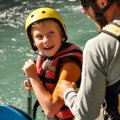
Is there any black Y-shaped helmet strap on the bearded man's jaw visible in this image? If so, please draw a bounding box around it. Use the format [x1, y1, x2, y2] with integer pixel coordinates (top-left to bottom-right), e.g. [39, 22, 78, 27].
[88, 0, 115, 29]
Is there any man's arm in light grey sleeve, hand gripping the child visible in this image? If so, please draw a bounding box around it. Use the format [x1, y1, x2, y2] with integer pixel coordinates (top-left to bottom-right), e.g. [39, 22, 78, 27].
[59, 41, 106, 120]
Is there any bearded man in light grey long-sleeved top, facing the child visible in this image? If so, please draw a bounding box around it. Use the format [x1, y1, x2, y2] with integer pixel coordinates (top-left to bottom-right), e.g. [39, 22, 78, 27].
[58, 0, 120, 120]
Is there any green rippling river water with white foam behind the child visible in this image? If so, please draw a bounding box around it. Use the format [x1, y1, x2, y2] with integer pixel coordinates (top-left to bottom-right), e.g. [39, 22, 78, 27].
[0, 0, 98, 120]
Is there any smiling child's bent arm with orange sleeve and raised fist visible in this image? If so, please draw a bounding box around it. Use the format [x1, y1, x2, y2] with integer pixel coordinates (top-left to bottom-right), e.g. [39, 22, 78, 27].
[23, 60, 81, 116]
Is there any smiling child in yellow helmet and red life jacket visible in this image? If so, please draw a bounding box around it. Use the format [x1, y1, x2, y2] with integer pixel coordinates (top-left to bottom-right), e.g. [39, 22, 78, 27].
[23, 7, 82, 120]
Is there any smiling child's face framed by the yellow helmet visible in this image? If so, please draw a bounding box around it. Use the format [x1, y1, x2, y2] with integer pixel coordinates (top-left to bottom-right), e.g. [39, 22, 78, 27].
[32, 21, 62, 57]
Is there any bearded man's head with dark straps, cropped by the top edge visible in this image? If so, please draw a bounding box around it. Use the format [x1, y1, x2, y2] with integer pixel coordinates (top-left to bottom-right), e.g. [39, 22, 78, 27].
[80, 0, 120, 29]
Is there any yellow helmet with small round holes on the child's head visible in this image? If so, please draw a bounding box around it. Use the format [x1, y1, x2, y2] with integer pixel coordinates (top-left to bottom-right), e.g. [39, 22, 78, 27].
[25, 7, 67, 51]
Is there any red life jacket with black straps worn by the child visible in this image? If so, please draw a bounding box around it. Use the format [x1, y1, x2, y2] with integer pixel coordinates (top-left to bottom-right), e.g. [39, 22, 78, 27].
[36, 43, 82, 119]
